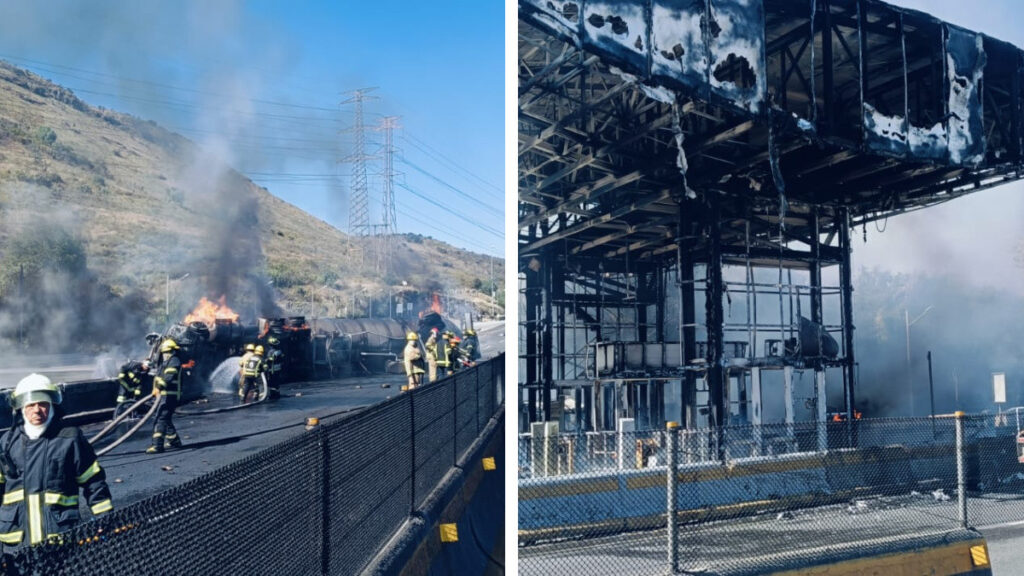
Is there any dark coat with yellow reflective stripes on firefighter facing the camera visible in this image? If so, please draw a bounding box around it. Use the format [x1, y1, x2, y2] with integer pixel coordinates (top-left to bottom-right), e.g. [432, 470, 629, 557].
[0, 416, 114, 547]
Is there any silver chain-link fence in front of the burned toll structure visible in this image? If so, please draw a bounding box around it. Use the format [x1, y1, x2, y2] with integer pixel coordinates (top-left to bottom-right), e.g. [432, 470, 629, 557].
[518, 415, 1007, 575]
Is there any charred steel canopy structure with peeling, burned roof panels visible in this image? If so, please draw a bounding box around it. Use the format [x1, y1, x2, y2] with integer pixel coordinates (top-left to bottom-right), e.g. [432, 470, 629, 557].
[518, 0, 1022, 444]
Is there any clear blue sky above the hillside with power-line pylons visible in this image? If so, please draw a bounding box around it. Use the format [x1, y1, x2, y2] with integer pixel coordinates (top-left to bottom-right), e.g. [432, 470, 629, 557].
[0, 0, 505, 255]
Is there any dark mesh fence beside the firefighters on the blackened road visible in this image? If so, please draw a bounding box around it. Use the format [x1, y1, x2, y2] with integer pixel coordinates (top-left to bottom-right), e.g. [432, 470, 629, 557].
[4, 355, 505, 576]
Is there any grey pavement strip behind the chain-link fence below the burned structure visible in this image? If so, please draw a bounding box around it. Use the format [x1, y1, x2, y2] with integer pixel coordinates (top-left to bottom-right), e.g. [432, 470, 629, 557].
[519, 492, 1024, 576]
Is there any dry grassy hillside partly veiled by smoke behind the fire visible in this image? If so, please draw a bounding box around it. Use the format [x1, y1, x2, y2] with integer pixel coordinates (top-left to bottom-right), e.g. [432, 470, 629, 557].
[0, 61, 504, 351]
